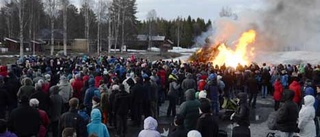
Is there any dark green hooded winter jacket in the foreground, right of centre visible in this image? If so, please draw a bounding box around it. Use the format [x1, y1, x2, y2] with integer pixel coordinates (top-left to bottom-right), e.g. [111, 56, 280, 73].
[179, 89, 200, 130]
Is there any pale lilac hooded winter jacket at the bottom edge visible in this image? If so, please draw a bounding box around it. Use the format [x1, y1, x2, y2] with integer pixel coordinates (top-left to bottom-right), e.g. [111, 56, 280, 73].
[138, 117, 161, 137]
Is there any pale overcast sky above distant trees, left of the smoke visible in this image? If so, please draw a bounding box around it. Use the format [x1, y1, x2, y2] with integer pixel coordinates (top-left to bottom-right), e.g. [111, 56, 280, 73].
[137, 0, 261, 20]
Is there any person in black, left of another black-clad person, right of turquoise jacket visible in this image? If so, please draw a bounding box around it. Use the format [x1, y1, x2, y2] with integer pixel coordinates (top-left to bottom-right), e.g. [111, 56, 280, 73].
[114, 84, 130, 136]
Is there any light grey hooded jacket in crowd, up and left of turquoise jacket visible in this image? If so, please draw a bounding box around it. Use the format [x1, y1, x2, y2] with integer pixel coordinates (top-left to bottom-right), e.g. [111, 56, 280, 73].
[58, 81, 73, 103]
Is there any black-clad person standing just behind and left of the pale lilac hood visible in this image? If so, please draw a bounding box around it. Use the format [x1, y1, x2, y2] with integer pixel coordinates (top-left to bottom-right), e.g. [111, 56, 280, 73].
[130, 77, 144, 126]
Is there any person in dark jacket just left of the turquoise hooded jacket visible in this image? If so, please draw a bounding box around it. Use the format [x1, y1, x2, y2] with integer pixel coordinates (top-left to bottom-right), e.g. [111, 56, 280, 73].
[58, 98, 87, 137]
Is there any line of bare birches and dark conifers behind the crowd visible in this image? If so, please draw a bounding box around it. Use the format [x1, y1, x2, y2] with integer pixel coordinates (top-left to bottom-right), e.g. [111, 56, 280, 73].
[0, 0, 211, 55]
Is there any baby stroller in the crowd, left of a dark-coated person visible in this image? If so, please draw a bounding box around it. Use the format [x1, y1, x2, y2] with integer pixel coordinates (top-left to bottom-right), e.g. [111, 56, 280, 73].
[221, 97, 237, 120]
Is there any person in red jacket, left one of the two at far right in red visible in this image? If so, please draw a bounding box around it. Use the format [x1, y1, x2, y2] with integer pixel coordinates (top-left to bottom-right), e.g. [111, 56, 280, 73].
[273, 78, 283, 111]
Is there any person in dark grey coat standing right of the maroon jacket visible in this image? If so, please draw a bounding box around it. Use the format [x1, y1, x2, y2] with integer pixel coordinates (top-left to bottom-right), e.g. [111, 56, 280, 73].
[49, 86, 63, 137]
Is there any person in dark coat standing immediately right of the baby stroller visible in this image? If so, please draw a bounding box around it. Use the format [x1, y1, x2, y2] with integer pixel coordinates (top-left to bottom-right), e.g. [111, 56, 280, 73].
[232, 92, 250, 127]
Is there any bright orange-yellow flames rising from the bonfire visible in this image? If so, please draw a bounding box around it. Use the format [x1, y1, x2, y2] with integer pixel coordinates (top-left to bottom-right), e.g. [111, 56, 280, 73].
[211, 30, 256, 68]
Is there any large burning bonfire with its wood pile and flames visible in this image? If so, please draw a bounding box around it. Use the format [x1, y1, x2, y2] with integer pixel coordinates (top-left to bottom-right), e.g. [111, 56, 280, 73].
[189, 30, 256, 68]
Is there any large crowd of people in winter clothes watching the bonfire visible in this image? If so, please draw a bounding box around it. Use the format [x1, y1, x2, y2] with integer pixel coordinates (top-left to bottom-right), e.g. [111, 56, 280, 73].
[0, 55, 320, 137]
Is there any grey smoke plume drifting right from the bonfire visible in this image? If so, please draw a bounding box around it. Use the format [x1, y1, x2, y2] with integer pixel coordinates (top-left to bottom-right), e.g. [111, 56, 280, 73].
[195, 0, 320, 51]
